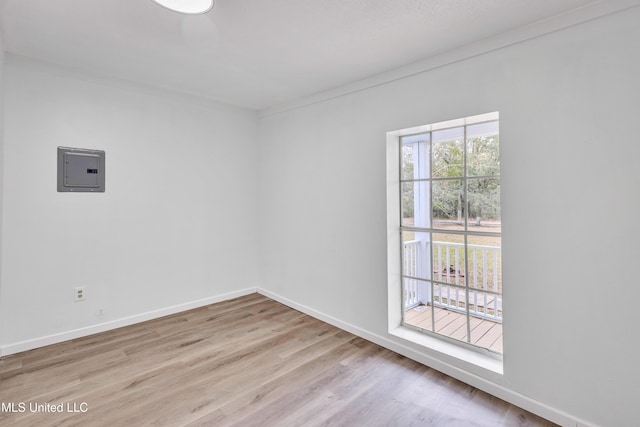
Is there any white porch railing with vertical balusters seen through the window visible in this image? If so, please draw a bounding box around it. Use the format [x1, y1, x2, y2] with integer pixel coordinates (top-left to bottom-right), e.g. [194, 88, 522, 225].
[403, 240, 502, 321]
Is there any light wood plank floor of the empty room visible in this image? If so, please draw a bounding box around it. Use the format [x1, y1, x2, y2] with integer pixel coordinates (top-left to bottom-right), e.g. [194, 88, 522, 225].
[0, 294, 553, 427]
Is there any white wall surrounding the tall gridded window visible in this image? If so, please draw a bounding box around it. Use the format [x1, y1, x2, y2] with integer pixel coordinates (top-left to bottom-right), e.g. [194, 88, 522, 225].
[259, 7, 640, 426]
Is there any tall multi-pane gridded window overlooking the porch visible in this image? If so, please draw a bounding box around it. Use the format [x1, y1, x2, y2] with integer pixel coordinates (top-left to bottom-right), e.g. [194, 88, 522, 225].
[397, 113, 502, 353]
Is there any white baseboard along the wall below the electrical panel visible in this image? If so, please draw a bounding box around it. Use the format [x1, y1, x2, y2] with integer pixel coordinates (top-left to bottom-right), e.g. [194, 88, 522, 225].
[0, 288, 257, 357]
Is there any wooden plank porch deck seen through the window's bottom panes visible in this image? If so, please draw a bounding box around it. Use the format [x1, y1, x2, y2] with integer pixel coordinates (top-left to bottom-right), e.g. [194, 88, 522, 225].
[404, 305, 502, 353]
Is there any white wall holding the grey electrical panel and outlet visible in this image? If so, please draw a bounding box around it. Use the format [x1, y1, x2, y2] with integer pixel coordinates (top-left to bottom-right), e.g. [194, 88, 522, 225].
[0, 55, 258, 348]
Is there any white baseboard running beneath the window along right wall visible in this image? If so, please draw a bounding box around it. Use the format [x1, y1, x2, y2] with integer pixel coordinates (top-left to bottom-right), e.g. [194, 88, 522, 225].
[257, 288, 596, 427]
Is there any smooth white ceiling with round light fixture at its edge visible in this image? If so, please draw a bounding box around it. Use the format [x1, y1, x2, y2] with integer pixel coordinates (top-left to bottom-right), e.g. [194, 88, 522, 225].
[0, 0, 598, 109]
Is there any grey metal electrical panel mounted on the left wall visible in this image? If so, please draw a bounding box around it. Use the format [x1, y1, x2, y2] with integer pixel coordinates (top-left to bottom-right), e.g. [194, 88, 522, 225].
[58, 147, 105, 193]
